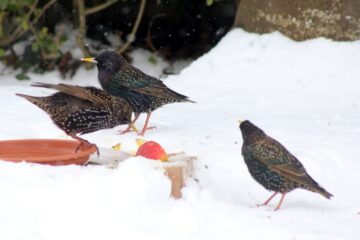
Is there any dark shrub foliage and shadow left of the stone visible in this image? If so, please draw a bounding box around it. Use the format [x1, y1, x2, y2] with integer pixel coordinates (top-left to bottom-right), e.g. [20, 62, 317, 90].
[0, 0, 236, 78]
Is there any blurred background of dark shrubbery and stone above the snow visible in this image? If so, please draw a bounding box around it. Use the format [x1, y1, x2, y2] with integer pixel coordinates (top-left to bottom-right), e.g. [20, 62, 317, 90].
[0, 0, 360, 80]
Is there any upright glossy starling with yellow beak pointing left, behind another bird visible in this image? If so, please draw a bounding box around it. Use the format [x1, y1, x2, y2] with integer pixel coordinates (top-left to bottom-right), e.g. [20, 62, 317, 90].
[81, 51, 194, 136]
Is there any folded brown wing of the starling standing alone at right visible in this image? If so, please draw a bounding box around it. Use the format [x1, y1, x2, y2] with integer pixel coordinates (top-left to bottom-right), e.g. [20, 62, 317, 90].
[254, 138, 313, 185]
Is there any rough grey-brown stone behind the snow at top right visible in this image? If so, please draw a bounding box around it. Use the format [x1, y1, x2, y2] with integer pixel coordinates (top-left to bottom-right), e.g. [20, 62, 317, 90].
[235, 0, 360, 40]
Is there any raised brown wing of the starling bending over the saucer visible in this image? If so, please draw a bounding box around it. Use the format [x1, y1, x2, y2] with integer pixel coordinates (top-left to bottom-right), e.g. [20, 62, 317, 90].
[31, 82, 107, 105]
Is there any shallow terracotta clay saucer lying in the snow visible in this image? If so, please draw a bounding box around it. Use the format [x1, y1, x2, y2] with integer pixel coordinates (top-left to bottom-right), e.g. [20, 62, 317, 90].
[0, 139, 96, 165]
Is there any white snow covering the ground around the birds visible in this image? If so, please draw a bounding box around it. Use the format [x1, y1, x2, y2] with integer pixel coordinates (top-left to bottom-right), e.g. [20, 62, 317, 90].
[0, 29, 360, 240]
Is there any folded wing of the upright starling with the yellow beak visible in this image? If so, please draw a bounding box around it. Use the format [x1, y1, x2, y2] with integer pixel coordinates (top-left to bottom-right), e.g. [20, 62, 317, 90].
[114, 68, 190, 101]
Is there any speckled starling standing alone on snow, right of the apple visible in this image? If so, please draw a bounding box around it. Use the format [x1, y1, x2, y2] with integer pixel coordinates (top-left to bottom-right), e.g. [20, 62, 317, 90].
[240, 120, 333, 210]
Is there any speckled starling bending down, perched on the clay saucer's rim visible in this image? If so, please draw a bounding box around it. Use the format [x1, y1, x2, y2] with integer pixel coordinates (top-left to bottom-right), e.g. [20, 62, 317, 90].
[16, 83, 132, 155]
